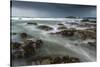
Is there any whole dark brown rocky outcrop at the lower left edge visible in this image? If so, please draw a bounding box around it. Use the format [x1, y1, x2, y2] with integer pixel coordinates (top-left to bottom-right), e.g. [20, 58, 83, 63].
[11, 39, 43, 59]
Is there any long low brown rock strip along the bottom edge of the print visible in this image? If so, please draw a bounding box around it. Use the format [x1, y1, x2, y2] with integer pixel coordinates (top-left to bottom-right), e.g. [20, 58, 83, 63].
[30, 56, 80, 64]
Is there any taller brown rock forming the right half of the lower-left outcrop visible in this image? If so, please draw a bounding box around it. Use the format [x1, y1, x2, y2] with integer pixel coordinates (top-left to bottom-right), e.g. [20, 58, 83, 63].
[23, 39, 43, 57]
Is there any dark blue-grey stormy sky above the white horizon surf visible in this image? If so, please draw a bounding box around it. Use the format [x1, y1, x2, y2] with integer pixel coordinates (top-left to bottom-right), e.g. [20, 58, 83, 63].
[11, 1, 96, 18]
